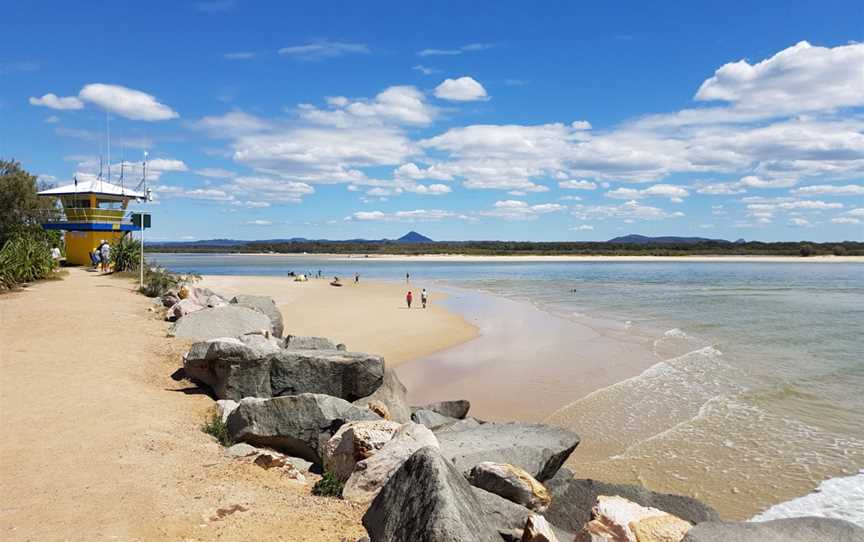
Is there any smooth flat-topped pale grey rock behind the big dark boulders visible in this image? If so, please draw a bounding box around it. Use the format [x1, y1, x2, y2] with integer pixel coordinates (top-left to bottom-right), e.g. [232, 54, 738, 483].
[168, 305, 270, 340]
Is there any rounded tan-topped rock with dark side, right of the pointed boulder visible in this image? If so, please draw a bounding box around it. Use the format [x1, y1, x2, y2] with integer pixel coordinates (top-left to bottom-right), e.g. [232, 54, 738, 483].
[468, 461, 552, 512]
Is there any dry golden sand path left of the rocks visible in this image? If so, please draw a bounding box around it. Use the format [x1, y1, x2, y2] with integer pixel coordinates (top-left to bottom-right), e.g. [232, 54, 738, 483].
[0, 269, 363, 541]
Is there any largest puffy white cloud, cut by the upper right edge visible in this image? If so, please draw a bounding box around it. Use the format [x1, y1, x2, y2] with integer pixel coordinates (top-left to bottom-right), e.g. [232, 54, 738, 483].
[695, 41, 864, 114]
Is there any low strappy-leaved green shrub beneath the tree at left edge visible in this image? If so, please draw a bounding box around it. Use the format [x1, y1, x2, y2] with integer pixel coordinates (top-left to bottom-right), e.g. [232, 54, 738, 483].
[0, 230, 54, 290]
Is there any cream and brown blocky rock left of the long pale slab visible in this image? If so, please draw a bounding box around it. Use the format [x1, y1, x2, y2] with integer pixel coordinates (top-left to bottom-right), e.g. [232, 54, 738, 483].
[323, 420, 402, 482]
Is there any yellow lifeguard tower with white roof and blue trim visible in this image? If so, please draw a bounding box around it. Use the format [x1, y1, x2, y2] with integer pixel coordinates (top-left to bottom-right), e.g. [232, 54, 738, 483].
[39, 179, 147, 265]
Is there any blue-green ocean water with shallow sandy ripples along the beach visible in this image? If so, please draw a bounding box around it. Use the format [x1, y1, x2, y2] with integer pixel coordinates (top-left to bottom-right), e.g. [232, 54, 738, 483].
[154, 255, 864, 525]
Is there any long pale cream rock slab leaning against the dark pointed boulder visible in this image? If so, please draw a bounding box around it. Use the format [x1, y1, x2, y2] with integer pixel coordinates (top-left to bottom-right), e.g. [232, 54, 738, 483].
[342, 423, 438, 503]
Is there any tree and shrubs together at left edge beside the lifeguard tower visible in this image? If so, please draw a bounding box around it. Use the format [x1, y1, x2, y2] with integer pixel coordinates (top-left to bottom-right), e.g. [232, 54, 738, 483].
[0, 160, 61, 290]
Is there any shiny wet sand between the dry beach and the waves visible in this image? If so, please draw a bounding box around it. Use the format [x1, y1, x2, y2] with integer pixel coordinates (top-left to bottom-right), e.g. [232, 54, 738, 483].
[398, 290, 657, 421]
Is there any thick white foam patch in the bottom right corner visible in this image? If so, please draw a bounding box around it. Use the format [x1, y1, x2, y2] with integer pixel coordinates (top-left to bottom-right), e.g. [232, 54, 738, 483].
[750, 470, 864, 527]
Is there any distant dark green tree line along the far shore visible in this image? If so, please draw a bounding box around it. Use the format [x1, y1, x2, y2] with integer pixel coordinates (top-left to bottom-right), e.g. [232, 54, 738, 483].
[147, 240, 864, 257]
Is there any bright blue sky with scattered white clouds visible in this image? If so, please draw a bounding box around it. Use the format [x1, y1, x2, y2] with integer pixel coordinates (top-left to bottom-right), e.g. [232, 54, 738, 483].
[0, 0, 864, 241]
